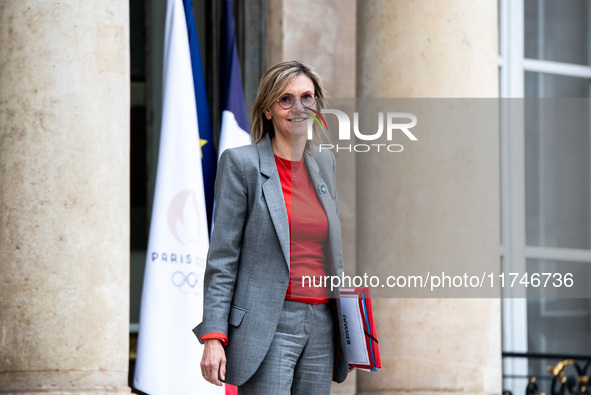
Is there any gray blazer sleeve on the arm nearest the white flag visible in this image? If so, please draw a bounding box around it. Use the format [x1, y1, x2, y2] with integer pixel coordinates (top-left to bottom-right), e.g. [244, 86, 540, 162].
[193, 149, 248, 343]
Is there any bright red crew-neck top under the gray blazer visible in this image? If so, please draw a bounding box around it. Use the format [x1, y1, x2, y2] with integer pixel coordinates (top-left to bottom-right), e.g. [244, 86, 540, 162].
[275, 155, 329, 304]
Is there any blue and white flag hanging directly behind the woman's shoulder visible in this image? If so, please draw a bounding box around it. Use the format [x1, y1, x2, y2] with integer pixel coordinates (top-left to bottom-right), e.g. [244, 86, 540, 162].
[218, 0, 250, 155]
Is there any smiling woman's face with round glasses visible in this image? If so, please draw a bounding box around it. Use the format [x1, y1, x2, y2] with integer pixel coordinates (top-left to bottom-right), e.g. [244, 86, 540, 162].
[265, 74, 316, 144]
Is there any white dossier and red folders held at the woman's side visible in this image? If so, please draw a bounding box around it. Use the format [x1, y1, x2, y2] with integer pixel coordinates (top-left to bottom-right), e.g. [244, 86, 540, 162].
[340, 287, 382, 372]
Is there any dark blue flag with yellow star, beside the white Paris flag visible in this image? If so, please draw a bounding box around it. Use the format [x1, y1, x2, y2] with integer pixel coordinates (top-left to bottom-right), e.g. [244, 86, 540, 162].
[183, 0, 217, 230]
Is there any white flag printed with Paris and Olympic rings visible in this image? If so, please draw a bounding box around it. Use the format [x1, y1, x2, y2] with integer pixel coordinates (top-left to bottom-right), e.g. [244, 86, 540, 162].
[134, 0, 224, 395]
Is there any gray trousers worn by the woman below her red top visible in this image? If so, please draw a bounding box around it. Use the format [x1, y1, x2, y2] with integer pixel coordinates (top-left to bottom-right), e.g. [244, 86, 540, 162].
[238, 300, 335, 395]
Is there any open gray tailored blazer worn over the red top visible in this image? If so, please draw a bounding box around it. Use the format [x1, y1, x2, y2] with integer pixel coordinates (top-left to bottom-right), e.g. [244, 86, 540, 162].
[193, 137, 348, 386]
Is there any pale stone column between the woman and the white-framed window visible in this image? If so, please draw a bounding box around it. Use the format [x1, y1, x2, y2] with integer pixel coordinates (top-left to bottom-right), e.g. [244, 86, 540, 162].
[357, 0, 502, 394]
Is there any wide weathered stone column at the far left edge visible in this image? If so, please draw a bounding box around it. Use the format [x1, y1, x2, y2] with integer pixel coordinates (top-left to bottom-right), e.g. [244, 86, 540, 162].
[0, 0, 130, 394]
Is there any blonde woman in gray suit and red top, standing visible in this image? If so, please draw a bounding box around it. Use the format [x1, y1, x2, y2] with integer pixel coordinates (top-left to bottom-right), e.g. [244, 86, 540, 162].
[194, 61, 348, 394]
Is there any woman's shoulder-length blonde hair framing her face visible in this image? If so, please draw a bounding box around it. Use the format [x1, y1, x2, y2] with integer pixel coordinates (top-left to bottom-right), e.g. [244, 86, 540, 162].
[251, 60, 326, 152]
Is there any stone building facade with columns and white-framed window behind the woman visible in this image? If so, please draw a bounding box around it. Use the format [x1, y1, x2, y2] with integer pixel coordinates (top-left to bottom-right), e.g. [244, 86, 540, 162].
[0, 0, 591, 394]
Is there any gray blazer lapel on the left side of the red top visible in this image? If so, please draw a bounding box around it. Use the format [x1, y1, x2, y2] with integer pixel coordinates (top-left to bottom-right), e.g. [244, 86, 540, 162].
[257, 137, 290, 269]
